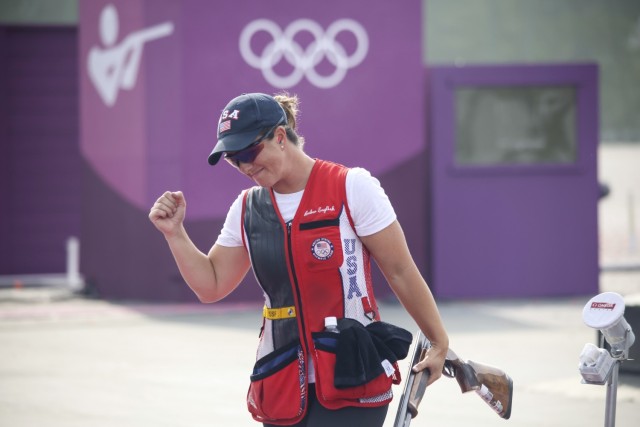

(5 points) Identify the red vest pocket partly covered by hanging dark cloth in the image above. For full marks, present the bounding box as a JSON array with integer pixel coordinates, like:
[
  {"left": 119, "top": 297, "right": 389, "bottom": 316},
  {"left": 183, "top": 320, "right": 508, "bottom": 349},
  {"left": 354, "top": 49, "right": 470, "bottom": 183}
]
[{"left": 312, "top": 332, "right": 393, "bottom": 400}]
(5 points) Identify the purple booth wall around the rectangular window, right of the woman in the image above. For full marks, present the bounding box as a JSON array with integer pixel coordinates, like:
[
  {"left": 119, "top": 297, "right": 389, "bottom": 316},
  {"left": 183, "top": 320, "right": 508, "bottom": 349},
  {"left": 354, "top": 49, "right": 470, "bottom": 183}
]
[{"left": 429, "top": 64, "right": 599, "bottom": 298}]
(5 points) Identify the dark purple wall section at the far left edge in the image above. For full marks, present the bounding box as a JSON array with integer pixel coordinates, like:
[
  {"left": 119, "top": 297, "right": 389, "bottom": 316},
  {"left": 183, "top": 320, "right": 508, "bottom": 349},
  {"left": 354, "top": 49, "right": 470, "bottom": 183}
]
[{"left": 0, "top": 27, "right": 81, "bottom": 274}]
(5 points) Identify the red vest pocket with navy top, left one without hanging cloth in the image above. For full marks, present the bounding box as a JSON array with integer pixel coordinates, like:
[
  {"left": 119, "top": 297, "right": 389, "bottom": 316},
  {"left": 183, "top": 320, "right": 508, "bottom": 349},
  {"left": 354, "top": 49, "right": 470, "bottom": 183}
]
[{"left": 247, "top": 341, "right": 307, "bottom": 422}]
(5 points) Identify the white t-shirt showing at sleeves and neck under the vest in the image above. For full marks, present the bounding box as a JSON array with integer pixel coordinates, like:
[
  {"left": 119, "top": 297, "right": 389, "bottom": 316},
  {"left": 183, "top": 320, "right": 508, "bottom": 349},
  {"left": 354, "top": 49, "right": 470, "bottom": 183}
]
[{"left": 216, "top": 168, "right": 396, "bottom": 247}]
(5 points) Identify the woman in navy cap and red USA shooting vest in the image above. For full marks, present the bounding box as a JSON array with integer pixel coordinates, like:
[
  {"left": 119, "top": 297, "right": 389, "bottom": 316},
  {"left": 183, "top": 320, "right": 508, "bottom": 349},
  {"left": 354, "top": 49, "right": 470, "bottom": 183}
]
[{"left": 149, "top": 93, "right": 449, "bottom": 427}]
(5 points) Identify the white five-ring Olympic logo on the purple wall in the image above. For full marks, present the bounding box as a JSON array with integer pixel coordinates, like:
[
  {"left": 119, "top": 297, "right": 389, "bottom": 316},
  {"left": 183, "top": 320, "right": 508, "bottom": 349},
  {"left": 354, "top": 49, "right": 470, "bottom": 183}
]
[{"left": 240, "top": 18, "right": 369, "bottom": 89}]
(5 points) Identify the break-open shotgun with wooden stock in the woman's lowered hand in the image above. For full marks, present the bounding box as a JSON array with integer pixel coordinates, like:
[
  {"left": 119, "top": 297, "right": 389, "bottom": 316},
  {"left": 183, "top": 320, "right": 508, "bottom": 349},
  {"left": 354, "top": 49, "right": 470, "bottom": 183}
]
[{"left": 393, "top": 331, "right": 513, "bottom": 427}]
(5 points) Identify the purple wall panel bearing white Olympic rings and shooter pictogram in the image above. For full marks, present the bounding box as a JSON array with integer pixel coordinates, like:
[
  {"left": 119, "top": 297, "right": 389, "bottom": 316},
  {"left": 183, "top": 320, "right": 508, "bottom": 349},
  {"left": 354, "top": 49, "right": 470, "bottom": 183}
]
[{"left": 79, "top": 0, "right": 426, "bottom": 299}]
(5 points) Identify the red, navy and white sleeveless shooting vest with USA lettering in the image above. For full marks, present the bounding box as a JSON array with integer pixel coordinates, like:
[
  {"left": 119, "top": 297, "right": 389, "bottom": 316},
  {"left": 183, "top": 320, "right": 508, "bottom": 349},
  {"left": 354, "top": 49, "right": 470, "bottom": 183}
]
[{"left": 242, "top": 160, "right": 400, "bottom": 425}]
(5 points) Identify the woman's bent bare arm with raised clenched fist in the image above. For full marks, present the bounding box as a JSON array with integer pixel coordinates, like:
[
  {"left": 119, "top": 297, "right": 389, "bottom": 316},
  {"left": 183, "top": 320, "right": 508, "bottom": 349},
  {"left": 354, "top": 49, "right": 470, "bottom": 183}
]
[{"left": 149, "top": 191, "right": 250, "bottom": 302}]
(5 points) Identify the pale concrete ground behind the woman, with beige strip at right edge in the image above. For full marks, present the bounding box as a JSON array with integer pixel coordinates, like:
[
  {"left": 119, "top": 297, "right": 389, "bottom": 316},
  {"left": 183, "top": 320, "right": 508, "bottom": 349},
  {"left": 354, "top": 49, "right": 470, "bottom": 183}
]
[{"left": 0, "top": 145, "right": 640, "bottom": 427}]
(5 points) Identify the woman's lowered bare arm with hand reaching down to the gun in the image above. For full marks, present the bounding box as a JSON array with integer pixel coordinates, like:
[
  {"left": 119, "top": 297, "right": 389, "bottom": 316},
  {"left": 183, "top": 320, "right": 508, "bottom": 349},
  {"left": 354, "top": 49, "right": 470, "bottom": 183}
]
[{"left": 361, "top": 221, "right": 449, "bottom": 384}]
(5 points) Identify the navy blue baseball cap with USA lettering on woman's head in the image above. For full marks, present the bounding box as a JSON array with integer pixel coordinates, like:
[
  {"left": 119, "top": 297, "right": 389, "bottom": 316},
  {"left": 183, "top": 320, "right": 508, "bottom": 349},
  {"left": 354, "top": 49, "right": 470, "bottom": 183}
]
[{"left": 209, "top": 93, "right": 287, "bottom": 165}]
